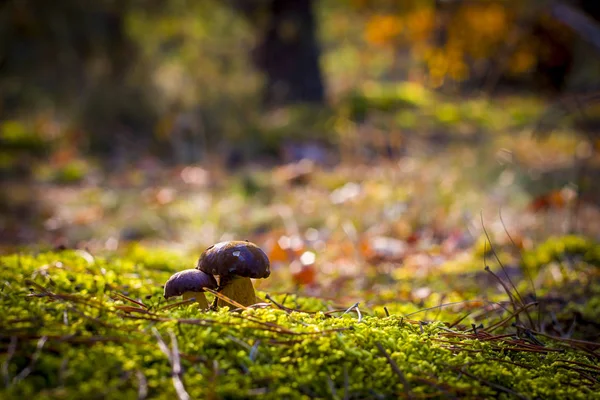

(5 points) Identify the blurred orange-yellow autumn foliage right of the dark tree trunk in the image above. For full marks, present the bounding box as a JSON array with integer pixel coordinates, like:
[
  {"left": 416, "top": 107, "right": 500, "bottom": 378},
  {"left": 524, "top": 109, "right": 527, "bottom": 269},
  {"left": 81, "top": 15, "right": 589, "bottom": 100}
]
[{"left": 364, "top": 2, "right": 537, "bottom": 86}]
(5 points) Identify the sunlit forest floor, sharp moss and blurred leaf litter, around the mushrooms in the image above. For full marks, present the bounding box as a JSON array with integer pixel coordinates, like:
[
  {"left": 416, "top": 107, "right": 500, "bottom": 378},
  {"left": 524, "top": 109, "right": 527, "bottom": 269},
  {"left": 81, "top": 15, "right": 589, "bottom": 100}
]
[{"left": 0, "top": 90, "right": 600, "bottom": 398}]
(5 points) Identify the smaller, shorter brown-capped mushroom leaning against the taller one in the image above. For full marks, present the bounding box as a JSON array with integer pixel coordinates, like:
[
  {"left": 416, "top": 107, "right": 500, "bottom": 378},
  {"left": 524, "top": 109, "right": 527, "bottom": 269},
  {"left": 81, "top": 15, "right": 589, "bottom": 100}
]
[{"left": 164, "top": 269, "right": 217, "bottom": 309}]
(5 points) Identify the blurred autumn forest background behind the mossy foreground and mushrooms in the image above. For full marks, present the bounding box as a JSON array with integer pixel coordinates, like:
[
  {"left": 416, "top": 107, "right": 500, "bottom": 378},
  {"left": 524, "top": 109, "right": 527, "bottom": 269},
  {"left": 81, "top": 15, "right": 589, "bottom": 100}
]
[{"left": 0, "top": 0, "right": 600, "bottom": 296}]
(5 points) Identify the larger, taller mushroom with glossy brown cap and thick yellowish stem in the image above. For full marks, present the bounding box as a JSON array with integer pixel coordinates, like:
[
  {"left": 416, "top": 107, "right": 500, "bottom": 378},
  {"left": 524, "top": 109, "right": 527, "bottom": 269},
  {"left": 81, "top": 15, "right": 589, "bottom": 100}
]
[{"left": 196, "top": 240, "right": 271, "bottom": 306}]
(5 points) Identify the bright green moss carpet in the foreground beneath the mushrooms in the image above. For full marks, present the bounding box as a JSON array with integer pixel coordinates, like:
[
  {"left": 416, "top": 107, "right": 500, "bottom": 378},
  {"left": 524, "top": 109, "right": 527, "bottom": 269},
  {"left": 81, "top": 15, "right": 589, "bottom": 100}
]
[{"left": 0, "top": 239, "right": 600, "bottom": 399}]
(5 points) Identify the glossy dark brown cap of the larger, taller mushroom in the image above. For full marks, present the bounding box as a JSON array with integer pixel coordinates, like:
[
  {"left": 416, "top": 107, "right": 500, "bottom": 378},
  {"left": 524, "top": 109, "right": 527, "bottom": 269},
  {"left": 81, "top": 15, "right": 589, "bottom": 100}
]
[{"left": 196, "top": 240, "right": 271, "bottom": 279}]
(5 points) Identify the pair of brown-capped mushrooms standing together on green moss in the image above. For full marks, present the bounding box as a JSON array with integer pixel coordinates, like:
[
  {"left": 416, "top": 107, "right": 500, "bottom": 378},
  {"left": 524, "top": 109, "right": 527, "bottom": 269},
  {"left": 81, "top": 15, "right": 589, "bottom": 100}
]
[{"left": 164, "top": 241, "right": 271, "bottom": 309}]
